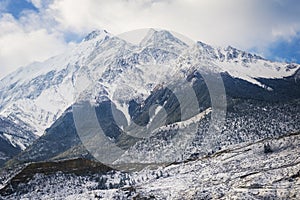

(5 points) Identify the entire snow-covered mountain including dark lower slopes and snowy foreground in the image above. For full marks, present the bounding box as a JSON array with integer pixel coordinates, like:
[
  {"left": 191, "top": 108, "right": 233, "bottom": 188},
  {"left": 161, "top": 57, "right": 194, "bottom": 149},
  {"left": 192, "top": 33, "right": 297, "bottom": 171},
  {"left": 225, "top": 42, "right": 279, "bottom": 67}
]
[{"left": 0, "top": 29, "right": 300, "bottom": 199}]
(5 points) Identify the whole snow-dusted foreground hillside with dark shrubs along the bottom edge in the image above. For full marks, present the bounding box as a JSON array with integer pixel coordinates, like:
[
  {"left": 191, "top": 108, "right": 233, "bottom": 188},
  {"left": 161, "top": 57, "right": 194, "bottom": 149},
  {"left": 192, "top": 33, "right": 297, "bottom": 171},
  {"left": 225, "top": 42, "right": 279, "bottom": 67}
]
[{"left": 1, "top": 133, "right": 300, "bottom": 200}]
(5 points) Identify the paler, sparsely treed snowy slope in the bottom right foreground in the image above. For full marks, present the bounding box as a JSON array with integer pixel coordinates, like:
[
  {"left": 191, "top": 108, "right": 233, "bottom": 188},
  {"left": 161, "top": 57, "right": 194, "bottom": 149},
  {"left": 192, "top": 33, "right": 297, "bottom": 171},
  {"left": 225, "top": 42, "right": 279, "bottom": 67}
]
[{"left": 132, "top": 134, "right": 300, "bottom": 199}]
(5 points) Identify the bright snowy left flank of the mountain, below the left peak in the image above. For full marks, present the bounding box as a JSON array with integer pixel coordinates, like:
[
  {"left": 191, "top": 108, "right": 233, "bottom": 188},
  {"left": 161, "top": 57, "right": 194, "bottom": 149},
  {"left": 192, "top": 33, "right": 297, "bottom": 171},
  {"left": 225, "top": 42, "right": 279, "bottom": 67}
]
[{"left": 0, "top": 31, "right": 109, "bottom": 135}]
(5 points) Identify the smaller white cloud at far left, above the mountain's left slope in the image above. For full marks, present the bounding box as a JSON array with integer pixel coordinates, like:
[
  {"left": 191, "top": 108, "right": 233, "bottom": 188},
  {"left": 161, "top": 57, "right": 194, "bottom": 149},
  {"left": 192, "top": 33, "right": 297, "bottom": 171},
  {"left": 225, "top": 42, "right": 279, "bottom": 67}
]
[{"left": 0, "top": 14, "right": 67, "bottom": 78}]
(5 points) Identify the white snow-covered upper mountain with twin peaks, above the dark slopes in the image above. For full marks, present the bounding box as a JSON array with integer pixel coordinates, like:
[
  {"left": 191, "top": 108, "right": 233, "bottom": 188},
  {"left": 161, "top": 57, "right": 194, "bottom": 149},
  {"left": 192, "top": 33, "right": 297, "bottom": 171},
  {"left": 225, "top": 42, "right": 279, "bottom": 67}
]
[{"left": 0, "top": 29, "right": 299, "bottom": 144}]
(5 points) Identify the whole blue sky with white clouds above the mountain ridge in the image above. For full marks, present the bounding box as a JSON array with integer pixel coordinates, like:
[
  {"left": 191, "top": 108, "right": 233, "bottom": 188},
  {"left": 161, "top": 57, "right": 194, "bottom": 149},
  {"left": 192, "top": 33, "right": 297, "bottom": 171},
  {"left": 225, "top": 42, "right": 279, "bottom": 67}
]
[{"left": 0, "top": 0, "right": 300, "bottom": 79}]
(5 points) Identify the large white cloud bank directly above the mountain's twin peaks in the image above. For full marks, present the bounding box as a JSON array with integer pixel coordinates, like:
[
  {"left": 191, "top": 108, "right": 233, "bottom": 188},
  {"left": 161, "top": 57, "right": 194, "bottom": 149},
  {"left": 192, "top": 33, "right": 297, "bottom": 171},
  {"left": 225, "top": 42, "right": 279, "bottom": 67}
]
[{"left": 50, "top": 0, "right": 300, "bottom": 48}]
